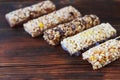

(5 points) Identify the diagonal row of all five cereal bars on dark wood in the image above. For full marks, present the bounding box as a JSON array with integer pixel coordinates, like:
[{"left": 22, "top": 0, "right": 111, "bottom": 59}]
[{"left": 5, "top": 0, "right": 120, "bottom": 69}]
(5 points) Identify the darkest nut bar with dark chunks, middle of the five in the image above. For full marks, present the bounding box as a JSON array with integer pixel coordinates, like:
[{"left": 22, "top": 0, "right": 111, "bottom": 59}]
[{"left": 43, "top": 15, "right": 100, "bottom": 46}]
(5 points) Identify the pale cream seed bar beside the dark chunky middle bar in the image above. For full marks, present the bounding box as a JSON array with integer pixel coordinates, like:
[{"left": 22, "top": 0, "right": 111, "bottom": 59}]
[{"left": 61, "top": 23, "right": 116, "bottom": 55}]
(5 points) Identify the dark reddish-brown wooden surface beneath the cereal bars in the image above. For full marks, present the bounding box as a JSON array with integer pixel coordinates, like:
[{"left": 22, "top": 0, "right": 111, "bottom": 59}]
[{"left": 0, "top": 0, "right": 120, "bottom": 80}]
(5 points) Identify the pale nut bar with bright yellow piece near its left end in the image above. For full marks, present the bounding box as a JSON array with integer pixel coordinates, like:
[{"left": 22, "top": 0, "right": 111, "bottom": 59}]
[{"left": 24, "top": 6, "right": 81, "bottom": 37}]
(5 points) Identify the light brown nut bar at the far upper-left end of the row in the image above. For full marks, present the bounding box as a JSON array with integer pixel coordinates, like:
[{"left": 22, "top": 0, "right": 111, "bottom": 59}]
[{"left": 5, "top": 0, "right": 56, "bottom": 27}]
